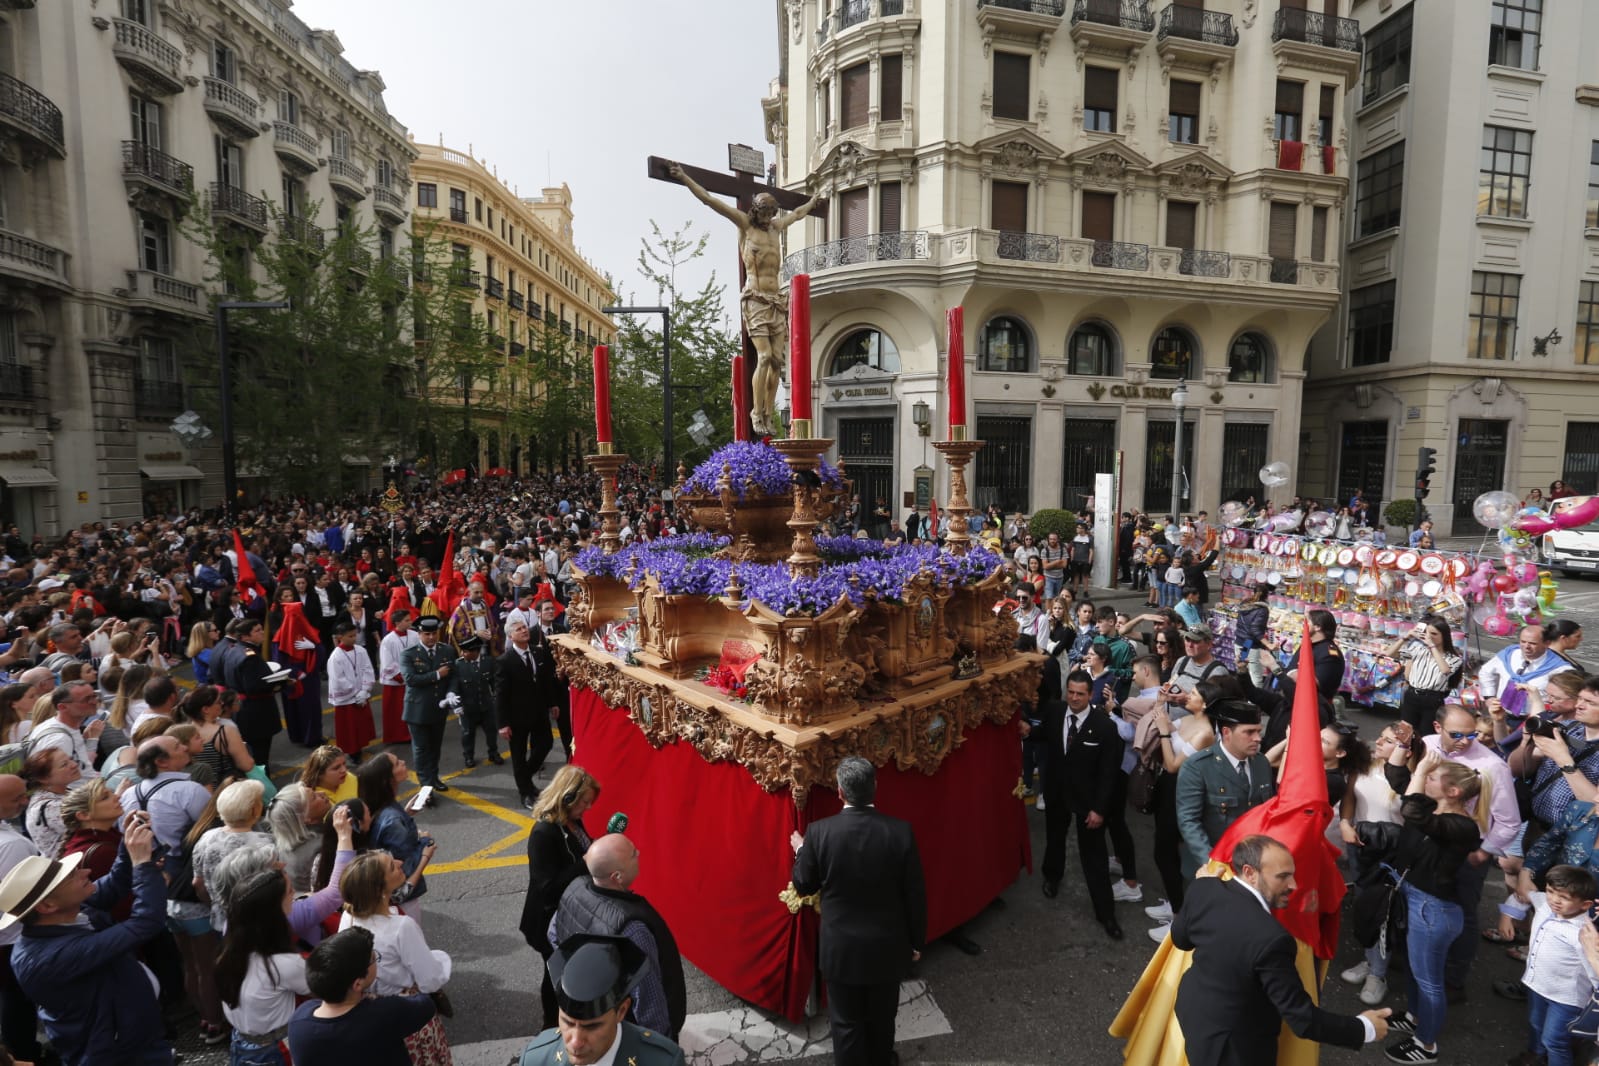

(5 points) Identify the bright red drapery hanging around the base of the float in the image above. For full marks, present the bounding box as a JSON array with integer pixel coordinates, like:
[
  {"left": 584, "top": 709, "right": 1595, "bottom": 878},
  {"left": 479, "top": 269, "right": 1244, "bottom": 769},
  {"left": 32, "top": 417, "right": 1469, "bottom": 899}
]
[{"left": 572, "top": 689, "right": 1031, "bottom": 1021}]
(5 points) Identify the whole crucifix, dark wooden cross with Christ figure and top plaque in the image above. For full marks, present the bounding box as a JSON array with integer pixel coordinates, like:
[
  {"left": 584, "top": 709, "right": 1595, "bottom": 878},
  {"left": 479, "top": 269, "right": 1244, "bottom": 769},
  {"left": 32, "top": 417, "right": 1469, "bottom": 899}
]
[{"left": 649, "top": 145, "right": 827, "bottom": 435}]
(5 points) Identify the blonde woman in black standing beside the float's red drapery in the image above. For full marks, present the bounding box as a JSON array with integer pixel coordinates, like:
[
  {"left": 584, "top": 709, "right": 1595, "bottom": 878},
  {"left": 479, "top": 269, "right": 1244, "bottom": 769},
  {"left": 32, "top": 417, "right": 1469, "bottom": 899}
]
[{"left": 521, "top": 762, "right": 600, "bottom": 1029}]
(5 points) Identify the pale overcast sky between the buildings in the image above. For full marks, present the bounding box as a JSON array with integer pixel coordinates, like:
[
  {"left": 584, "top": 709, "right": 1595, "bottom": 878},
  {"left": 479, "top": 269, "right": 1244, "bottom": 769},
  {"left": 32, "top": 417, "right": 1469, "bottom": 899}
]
[{"left": 294, "top": 0, "right": 777, "bottom": 315}]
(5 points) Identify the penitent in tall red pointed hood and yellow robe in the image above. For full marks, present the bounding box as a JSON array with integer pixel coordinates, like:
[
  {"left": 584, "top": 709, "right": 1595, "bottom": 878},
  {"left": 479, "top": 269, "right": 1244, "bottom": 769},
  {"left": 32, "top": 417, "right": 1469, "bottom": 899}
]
[{"left": 1110, "top": 622, "right": 1345, "bottom": 1066}]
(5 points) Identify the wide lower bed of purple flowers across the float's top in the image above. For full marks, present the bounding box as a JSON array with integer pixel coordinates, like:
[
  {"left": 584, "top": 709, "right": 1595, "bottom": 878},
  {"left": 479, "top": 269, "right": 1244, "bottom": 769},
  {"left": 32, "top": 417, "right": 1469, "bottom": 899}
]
[{"left": 576, "top": 534, "right": 1003, "bottom": 615}]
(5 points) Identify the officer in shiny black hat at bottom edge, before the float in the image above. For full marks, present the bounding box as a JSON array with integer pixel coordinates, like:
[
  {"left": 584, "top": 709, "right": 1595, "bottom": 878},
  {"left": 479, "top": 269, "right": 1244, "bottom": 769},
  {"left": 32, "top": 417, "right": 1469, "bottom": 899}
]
[{"left": 521, "top": 933, "right": 684, "bottom": 1066}]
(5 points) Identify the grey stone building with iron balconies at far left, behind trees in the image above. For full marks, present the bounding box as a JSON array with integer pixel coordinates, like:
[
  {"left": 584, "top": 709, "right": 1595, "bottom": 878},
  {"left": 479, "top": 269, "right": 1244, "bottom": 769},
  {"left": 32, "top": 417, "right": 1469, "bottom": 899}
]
[{"left": 0, "top": 0, "right": 416, "bottom": 534}]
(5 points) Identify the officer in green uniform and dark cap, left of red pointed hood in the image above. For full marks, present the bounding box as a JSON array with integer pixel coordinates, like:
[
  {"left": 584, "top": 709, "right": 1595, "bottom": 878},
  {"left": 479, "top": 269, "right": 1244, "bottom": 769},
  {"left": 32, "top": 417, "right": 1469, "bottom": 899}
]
[{"left": 1177, "top": 697, "right": 1278, "bottom": 877}]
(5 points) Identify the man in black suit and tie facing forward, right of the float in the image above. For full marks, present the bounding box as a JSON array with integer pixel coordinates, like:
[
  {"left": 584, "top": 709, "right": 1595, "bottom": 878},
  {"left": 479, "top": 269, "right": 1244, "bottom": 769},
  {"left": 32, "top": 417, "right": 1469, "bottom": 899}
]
[{"left": 1041, "top": 670, "right": 1122, "bottom": 940}]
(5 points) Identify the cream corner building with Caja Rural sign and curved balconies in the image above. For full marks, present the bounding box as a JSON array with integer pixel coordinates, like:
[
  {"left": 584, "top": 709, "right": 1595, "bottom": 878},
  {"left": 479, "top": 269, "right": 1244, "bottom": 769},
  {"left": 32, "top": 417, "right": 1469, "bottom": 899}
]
[{"left": 764, "top": 0, "right": 1361, "bottom": 513}]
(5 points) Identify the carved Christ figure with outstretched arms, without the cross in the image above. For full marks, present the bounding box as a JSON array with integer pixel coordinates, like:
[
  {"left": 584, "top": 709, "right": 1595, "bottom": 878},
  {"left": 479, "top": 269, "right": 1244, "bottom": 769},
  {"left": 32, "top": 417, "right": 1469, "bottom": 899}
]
[{"left": 668, "top": 163, "right": 819, "bottom": 436}]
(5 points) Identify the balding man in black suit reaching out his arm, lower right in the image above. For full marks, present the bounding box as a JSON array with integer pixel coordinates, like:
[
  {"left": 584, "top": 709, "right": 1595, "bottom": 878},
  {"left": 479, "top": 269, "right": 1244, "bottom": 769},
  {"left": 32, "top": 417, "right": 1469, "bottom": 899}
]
[{"left": 1172, "top": 836, "right": 1391, "bottom": 1066}]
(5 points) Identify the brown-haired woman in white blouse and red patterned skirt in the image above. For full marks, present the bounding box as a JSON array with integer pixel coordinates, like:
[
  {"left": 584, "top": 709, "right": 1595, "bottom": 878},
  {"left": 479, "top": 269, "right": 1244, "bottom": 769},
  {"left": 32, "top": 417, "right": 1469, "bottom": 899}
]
[{"left": 339, "top": 852, "right": 453, "bottom": 1066}]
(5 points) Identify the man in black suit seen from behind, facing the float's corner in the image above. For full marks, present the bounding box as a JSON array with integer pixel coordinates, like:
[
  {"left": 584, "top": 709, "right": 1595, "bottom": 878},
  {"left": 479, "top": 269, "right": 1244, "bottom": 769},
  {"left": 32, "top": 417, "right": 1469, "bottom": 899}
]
[{"left": 790, "top": 754, "right": 927, "bottom": 1066}]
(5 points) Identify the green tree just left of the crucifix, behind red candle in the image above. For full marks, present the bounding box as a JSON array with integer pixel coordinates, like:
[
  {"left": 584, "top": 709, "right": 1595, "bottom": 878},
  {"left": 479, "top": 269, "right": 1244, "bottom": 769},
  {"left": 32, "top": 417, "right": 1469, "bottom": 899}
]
[{"left": 611, "top": 222, "right": 740, "bottom": 476}]
